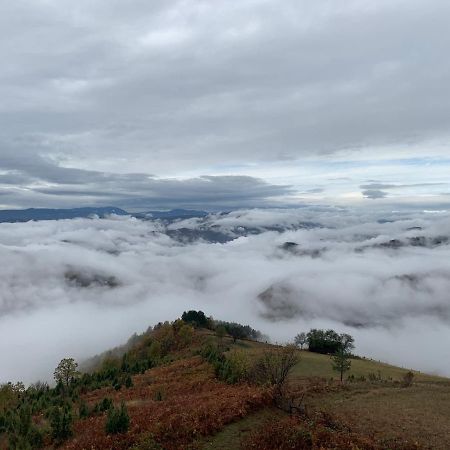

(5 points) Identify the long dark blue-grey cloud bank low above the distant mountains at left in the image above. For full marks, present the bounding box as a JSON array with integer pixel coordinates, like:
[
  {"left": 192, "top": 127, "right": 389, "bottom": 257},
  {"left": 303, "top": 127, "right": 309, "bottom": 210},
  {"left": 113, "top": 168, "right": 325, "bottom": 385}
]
[{"left": 0, "top": 145, "right": 294, "bottom": 211}]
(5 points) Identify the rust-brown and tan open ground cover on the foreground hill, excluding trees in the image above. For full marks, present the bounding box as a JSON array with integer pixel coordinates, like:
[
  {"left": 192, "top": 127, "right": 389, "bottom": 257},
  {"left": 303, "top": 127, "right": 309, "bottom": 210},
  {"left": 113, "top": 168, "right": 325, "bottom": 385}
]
[{"left": 0, "top": 330, "right": 442, "bottom": 450}]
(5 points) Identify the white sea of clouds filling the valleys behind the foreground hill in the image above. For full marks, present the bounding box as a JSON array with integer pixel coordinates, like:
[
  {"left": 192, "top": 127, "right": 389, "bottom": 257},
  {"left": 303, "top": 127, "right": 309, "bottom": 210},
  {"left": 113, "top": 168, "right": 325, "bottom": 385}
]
[{"left": 0, "top": 208, "right": 450, "bottom": 382}]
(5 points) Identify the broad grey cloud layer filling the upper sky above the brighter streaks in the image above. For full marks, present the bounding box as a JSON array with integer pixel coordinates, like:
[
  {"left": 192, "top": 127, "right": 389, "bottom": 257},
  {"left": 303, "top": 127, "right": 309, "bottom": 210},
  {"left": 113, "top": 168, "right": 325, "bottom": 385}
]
[{"left": 0, "top": 0, "right": 450, "bottom": 206}]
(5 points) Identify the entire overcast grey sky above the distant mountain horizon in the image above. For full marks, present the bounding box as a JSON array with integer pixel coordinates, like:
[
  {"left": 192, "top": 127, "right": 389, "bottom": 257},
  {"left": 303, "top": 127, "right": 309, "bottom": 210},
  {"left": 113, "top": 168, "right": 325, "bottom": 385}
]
[{"left": 0, "top": 0, "right": 450, "bottom": 210}]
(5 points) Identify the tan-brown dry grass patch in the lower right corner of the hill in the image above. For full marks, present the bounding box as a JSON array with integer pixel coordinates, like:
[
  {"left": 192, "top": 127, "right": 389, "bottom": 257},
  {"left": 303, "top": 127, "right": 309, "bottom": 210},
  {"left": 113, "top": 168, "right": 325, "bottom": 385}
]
[{"left": 306, "top": 382, "right": 450, "bottom": 449}]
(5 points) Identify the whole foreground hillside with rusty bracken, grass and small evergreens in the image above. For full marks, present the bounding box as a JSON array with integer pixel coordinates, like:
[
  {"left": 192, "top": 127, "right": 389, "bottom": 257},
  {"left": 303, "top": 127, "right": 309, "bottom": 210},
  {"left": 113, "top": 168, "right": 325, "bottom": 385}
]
[{"left": 0, "top": 317, "right": 450, "bottom": 450}]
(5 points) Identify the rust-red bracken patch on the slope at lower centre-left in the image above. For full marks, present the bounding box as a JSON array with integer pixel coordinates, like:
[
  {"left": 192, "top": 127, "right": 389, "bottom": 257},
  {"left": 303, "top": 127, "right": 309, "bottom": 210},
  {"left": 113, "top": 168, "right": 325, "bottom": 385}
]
[{"left": 63, "top": 357, "right": 271, "bottom": 450}]
